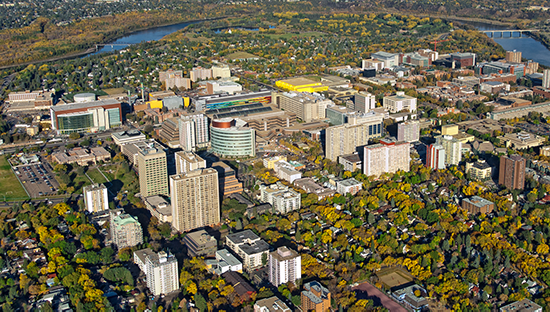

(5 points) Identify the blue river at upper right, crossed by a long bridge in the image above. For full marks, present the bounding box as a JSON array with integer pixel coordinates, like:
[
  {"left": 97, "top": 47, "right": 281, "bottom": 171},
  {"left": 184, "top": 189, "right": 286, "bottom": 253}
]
[{"left": 461, "top": 21, "right": 550, "bottom": 66}]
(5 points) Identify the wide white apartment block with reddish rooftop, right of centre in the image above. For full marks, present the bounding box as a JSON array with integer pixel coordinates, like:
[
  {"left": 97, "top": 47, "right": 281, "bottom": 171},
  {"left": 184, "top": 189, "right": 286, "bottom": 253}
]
[{"left": 363, "top": 140, "right": 411, "bottom": 176}]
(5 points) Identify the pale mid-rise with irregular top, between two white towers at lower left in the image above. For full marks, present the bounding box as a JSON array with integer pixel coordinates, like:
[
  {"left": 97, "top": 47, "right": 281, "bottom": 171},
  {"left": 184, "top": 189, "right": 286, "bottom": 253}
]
[{"left": 109, "top": 209, "right": 143, "bottom": 249}]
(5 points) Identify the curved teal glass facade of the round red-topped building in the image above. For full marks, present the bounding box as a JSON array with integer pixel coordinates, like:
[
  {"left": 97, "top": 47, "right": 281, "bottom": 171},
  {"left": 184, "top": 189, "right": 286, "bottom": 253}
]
[{"left": 210, "top": 127, "right": 256, "bottom": 158}]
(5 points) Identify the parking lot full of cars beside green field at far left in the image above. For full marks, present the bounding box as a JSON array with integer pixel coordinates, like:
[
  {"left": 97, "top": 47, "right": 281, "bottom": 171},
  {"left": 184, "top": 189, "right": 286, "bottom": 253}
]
[{"left": 13, "top": 163, "right": 59, "bottom": 198}]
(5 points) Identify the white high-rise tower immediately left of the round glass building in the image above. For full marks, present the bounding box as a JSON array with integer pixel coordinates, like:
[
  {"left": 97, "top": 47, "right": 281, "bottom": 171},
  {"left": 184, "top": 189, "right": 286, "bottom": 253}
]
[{"left": 178, "top": 114, "right": 210, "bottom": 151}]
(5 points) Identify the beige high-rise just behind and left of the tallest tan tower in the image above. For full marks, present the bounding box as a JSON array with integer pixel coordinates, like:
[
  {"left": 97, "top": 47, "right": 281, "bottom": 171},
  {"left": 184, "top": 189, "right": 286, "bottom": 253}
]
[{"left": 137, "top": 145, "right": 169, "bottom": 197}]
